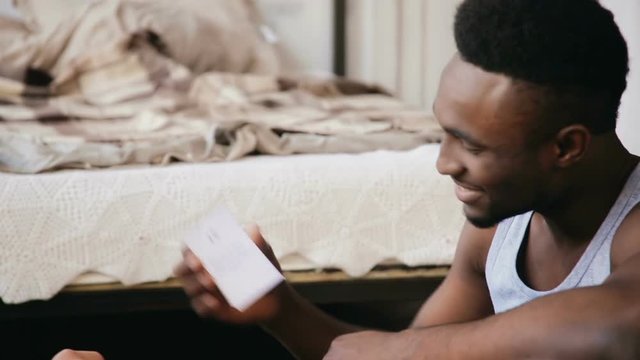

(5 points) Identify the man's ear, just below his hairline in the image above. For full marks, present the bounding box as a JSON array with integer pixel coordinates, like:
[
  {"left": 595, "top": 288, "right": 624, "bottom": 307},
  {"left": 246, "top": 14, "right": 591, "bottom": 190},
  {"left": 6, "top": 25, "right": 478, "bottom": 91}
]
[{"left": 554, "top": 124, "right": 591, "bottom": 168}]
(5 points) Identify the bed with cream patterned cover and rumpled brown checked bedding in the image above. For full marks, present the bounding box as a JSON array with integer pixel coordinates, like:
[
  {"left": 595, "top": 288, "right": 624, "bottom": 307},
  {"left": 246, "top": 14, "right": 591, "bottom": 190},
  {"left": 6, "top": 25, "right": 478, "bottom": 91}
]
[{"left": 0, "top": 1, "right": 463, "bottom": 315}]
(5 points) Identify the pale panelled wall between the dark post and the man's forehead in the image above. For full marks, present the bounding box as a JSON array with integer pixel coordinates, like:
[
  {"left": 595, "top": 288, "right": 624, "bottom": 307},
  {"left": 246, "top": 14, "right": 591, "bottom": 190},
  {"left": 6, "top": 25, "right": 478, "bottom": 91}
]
[{"left": 347, "top": 0, "right": 460, "bottom": 109}]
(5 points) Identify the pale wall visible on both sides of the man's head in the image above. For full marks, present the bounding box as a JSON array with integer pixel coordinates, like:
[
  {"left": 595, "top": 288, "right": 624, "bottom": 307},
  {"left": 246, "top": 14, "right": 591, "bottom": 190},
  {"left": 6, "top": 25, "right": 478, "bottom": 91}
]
[{"left": 347, "top": 0, "right": 640, "bottom": 155}]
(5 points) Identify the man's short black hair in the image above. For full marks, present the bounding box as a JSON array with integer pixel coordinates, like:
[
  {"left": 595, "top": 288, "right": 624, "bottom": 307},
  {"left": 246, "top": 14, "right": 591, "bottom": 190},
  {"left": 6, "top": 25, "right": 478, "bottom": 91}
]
[{"left": 454, "top": 0, "right": 629, "bottom": 133}]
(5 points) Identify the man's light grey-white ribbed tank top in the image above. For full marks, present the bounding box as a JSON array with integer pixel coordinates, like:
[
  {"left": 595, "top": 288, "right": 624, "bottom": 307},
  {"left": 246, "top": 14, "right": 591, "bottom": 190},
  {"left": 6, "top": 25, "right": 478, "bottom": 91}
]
[{"left": 485, "top": 164, "right": 640, "bottom": 314}]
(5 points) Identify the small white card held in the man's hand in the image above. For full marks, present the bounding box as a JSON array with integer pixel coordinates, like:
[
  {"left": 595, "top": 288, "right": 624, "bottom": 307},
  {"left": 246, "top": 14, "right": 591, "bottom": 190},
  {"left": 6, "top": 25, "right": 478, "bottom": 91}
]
[{"left": 186, "top": 208, "right": 284, "bottom": 311}]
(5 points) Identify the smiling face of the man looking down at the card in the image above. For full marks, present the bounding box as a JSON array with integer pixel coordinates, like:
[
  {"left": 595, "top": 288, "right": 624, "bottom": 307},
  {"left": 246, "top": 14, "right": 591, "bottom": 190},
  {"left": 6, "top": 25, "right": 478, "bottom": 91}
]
[{"left": 434, "top": 56, "right": 552, "bottom": 227}]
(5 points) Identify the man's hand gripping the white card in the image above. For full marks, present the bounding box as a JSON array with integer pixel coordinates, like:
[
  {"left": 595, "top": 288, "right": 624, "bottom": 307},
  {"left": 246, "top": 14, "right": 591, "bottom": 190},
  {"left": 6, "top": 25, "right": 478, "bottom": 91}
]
[{"left": 174, "top": 225, "right": 290, "bottom": 324}]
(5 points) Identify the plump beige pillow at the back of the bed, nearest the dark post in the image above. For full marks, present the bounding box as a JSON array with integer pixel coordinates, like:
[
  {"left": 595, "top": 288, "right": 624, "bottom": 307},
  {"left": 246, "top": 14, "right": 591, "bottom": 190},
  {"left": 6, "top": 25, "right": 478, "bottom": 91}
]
[{"left": 120, "top": 0, "right": 279, "bottom": 74}]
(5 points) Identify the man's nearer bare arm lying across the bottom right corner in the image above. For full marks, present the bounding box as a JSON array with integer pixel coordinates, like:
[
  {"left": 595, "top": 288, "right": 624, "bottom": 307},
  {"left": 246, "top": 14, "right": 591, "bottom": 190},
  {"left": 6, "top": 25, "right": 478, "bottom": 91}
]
[{"left": 327, "top": 211, "right": 640, "bottom": 360}]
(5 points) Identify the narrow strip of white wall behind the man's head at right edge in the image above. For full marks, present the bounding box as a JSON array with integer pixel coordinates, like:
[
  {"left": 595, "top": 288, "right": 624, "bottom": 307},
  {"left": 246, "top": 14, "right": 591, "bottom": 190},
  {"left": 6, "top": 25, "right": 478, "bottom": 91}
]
[{"left": 601, "top": 0, "right": 640, "bottom": 155}]
